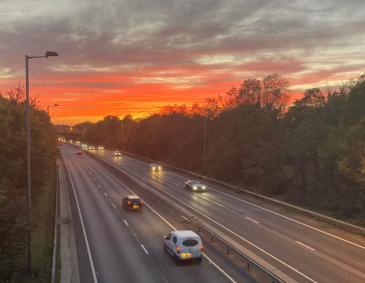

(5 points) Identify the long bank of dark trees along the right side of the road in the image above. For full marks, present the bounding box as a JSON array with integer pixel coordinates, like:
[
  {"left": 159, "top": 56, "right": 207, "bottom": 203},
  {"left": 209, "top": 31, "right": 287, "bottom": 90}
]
[{"left": 68, "top": 74, "right": 365, "bottom": 225}]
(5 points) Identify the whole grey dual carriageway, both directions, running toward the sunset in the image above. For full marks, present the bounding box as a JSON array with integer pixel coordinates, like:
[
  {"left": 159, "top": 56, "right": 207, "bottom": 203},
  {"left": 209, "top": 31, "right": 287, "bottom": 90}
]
[{"left": 61, "top": 143, "right": 365, "bottom": 282}]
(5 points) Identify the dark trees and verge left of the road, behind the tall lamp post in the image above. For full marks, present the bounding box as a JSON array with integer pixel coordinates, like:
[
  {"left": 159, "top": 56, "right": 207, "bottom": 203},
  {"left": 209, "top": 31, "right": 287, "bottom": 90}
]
[{"left": 0, "top": 87, "right": 57, "bottom": 282}]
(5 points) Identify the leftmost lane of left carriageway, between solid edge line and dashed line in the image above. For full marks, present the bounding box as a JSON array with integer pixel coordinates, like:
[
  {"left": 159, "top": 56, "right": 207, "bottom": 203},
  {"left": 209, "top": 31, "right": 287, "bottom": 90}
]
[{"left": 64, "top": 150, "right": 164, "bottom": 282}]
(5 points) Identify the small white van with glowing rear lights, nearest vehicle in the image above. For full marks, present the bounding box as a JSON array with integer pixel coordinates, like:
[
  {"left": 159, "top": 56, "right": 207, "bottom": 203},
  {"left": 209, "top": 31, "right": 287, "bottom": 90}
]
[{"left": 164, "top": 230, "right": 203, "bottom": 262}]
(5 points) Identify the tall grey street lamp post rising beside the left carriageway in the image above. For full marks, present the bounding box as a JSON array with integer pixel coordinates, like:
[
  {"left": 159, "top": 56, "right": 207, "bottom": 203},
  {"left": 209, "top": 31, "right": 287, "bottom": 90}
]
[{"left": 25, "top": 51, "right": 58, "bottom": 273}]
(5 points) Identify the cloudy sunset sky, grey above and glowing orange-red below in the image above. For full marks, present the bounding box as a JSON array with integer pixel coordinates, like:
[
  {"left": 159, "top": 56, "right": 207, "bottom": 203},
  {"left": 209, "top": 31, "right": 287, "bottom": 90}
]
[{"left": 0, "top": 0, "right": 365, "bottom": 124}]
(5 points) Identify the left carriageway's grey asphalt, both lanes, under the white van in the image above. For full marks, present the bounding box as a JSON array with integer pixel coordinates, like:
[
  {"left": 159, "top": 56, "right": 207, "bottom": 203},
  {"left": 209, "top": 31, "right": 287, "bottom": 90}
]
[{"left": 62, "top": 147, "right": 235, "bottom": 282}]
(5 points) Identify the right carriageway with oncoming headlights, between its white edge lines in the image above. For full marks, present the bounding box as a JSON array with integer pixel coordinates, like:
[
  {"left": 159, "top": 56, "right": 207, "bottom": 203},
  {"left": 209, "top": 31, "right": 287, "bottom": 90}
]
[{"left": 86, "top": 146, "right": 365, "bottom": 282}]
